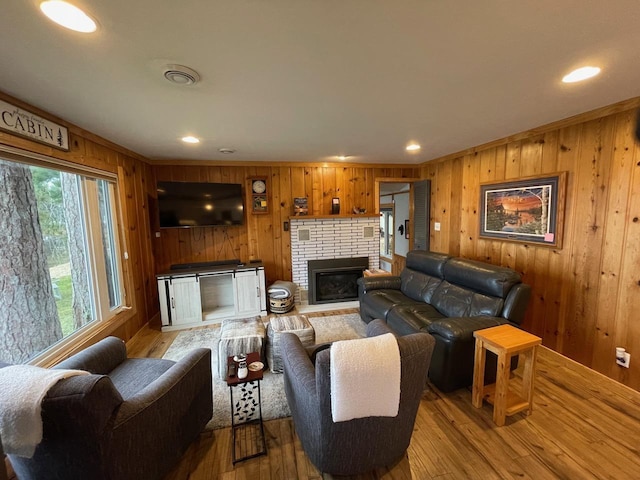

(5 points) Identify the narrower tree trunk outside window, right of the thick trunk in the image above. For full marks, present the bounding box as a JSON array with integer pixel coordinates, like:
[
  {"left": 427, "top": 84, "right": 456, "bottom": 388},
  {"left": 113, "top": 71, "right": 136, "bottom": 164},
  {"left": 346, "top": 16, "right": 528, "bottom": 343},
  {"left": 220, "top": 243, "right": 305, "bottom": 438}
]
[{"left": 60, "top": 173, "right": 92, "bottom": 330}]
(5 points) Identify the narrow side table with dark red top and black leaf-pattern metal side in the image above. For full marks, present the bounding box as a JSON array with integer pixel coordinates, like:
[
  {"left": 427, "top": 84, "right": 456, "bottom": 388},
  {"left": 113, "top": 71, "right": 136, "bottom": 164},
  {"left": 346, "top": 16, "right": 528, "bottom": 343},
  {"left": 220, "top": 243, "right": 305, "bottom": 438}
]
[{"left": 225, "top": 352, "right": 267, "bottom": 465}]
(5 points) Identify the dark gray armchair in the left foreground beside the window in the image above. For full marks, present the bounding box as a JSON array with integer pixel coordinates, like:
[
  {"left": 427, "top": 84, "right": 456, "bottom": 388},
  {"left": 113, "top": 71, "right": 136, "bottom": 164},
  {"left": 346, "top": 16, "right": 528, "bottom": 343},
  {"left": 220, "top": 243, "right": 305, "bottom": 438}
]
[{"left": 9, "top": 337, "right": 213, "bottom": 480}]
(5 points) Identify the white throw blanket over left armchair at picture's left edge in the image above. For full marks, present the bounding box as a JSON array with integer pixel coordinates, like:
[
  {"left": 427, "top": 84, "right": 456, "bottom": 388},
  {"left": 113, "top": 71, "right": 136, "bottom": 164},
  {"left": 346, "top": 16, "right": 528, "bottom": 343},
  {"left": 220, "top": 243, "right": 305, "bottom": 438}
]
[{"left": 0, "top": 365, "right": 89, "bottom": 458}]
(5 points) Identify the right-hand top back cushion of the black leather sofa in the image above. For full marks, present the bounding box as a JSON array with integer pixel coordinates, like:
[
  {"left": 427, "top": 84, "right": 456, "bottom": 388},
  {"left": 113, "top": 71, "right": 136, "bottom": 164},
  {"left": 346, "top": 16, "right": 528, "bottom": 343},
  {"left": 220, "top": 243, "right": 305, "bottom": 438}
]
[{"left": 444, "top": 258, "right": 521, "bottom": 298}]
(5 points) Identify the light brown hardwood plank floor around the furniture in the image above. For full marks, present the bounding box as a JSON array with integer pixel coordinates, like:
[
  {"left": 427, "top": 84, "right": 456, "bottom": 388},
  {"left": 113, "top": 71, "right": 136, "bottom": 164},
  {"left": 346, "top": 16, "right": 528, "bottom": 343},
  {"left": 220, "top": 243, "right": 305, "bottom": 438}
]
[{"left": 128, "top": 310, "right": 640, "bottom": 480}]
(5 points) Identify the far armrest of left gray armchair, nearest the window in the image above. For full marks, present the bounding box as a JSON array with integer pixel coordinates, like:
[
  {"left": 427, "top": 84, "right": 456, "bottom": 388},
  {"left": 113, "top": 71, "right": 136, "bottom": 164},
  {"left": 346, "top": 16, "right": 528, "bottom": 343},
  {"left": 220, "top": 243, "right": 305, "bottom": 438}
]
[{"left": 53, "top": 337, "right": 127, "bottom": 375}]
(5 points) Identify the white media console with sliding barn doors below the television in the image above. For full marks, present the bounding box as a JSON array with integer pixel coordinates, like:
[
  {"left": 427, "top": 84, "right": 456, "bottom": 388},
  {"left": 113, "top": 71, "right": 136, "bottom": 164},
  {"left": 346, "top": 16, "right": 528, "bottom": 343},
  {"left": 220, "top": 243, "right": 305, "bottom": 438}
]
[{"left": 156, "top": 263, "right": 267, "bottom": 331}]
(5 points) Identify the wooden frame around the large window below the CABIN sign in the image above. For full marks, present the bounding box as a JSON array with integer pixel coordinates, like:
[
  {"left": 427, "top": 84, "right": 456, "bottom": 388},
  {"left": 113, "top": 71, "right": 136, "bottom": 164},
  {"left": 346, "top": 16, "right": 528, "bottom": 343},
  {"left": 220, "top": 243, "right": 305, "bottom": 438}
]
[{"left": 0, "top": 144, "right": 137, "bottom": 368}]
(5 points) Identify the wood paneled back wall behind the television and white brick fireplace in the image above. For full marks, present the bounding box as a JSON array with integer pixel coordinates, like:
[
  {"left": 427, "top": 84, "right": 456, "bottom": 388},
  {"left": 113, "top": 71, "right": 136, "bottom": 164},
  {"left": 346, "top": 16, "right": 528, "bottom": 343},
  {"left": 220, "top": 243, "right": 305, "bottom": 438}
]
[{"left": 152, "top": 164, "right": 419, "bottom": 284}]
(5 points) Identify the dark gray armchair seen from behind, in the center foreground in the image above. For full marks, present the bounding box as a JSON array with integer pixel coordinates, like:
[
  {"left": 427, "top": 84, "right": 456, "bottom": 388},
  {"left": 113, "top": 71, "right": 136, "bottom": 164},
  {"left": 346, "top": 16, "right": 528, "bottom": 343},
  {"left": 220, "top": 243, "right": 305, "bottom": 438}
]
[{"left": 281, "top": 320, "right": 435, "bottom": 475}]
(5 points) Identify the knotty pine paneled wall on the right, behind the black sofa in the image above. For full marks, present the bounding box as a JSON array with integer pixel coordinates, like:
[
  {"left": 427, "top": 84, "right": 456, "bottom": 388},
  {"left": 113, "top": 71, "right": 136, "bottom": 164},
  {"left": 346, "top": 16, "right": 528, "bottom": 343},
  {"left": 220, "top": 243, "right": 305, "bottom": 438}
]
[{"left": 422, "top": 99, "right": 640, "bottom": 390}]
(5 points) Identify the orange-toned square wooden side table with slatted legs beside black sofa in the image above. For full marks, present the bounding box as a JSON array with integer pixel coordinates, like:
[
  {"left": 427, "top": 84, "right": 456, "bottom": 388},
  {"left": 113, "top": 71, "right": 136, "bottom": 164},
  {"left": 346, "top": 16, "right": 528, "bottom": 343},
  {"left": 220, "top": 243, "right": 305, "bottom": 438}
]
[{"left": 472, "top": 325, "right": 542, "bottom": 427}]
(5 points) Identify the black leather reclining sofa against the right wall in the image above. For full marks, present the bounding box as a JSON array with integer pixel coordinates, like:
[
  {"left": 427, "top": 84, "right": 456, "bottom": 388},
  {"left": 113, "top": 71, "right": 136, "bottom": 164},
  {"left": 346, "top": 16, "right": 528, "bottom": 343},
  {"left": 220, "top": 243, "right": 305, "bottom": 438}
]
[{"left": 358, "top": 250, "right": 531, "bottom": 392}]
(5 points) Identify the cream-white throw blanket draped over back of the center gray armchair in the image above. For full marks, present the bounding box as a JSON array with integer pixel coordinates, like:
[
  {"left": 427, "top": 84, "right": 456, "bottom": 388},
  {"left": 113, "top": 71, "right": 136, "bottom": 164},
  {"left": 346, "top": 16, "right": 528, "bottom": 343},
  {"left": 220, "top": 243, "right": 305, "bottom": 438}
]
[{"left": 331, "top": 333, "right": 400, "bottom": 422}]
